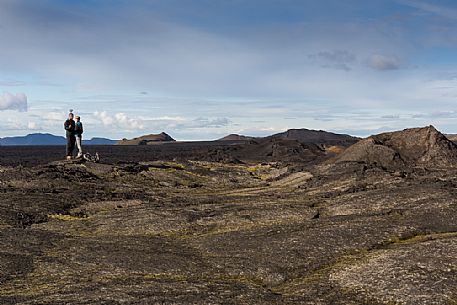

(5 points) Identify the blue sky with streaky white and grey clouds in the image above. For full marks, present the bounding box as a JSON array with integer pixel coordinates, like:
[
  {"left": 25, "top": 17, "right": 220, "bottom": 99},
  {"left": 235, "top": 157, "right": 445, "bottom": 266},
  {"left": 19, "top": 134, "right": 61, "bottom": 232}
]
[{"left": 0, "top": 0, "right": 457, "bottom": 140}]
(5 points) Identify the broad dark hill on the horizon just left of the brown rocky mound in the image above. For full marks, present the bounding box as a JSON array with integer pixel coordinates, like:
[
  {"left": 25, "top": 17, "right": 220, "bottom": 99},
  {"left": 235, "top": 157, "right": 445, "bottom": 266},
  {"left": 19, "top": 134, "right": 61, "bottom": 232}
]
[{"left": 266, "top": 129, "right": 360, "bottom": 147}]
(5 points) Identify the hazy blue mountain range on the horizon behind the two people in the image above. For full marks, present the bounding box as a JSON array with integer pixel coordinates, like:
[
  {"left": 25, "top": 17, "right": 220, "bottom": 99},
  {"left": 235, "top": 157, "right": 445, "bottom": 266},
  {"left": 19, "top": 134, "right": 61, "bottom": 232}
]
[{"left": 0, "top": 133, "right": 116, "bottom": 146}]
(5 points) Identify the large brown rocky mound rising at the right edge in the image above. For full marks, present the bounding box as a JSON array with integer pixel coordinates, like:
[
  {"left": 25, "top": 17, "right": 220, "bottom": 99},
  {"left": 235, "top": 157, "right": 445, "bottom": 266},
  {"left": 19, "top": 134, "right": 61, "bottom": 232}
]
[{"left": 336, "top": 126, "right": 457, "bottom": 168}]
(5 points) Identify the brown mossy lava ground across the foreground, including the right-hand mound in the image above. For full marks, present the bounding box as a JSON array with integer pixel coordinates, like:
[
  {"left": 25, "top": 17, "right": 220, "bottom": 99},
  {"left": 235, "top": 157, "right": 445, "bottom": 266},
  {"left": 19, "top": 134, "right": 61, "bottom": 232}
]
[{"left": 0, "top": 128, "right": 457, "bottom": 305}]
